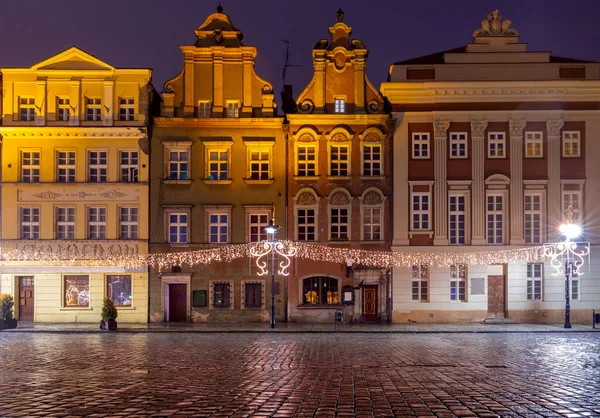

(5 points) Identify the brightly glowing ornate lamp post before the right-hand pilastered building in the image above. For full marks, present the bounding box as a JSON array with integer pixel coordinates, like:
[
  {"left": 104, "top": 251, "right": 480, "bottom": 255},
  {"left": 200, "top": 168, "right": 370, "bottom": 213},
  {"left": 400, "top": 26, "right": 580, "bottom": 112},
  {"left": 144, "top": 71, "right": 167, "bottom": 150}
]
[{"left": 544, "top": 206, "right": 590, "bottom": 328}]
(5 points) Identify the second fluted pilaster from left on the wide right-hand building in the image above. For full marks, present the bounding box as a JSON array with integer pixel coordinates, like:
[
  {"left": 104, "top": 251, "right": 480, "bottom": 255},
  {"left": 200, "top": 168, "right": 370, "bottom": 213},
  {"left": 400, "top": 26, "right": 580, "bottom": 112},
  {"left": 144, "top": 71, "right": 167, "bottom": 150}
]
[{"left": 471, "top": 120, "right": 487, "bottom": 245}]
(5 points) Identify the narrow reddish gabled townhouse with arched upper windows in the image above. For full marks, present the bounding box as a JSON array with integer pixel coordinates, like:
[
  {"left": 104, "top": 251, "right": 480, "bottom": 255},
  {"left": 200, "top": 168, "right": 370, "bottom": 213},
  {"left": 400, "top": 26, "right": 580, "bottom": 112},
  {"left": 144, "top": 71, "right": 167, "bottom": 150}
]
[{"left": 287, "top": 10, "right": 392, "bottom": 323}]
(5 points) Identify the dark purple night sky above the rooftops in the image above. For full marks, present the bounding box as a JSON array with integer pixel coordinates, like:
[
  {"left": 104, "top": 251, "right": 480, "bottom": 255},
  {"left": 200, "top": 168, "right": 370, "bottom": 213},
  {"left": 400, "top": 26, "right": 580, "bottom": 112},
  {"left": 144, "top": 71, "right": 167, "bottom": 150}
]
[{"left": 0, "top": 0, "right": 600, "bottom": 103}]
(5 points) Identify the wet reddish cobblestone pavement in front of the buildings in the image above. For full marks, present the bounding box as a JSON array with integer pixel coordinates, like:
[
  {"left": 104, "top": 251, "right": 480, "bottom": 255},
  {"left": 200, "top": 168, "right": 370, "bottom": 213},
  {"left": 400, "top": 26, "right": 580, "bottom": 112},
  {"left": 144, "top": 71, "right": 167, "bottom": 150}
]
[{"left": 0, "top": 333, "right": 600, "bottom": 417}]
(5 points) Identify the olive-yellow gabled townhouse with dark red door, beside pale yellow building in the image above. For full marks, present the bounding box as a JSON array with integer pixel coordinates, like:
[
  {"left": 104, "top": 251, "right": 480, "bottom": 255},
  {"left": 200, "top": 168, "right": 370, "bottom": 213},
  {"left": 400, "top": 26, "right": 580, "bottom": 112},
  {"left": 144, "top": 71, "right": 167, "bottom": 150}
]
[{"left": 150, "top": 6, "right": 285, "bottom": 322}]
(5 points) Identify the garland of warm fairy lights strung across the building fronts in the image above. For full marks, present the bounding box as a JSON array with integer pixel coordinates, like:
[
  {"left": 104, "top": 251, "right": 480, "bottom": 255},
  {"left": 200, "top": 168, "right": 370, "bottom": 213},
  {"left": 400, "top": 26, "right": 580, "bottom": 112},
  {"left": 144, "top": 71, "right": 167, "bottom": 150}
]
[{"left": 0, "top": 240, "right": 547, "bottom": 270}]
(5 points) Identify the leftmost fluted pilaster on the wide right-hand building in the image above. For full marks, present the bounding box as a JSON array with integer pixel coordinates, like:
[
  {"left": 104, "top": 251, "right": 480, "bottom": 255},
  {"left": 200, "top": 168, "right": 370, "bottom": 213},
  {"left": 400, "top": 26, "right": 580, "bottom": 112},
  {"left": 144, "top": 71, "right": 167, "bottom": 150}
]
[{"left": 433, "top": 119, "right": 450, "bottom": 245}]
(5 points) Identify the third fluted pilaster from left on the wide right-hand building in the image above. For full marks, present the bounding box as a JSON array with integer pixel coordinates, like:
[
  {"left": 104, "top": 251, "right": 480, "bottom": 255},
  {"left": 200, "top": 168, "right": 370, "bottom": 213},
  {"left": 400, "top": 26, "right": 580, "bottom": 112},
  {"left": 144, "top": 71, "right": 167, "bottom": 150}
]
[{"left": 509, "top": 119, "right": 527, "bottom": 245}]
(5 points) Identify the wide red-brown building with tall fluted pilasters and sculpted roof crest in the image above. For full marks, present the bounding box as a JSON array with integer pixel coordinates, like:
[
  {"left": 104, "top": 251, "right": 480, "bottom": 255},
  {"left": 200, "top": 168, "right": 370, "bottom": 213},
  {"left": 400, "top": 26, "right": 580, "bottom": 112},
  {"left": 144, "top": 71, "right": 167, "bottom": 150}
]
[{"left": 381, "top": 11, "right": 600, "bottom": 323}]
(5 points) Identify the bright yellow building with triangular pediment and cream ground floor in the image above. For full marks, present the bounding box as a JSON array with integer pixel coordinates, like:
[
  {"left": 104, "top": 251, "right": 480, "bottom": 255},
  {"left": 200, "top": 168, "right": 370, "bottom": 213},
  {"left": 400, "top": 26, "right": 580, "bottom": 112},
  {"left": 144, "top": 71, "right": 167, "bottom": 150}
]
[{"left": 0, "top": 47, "right": 156, "bottom": 322}]
